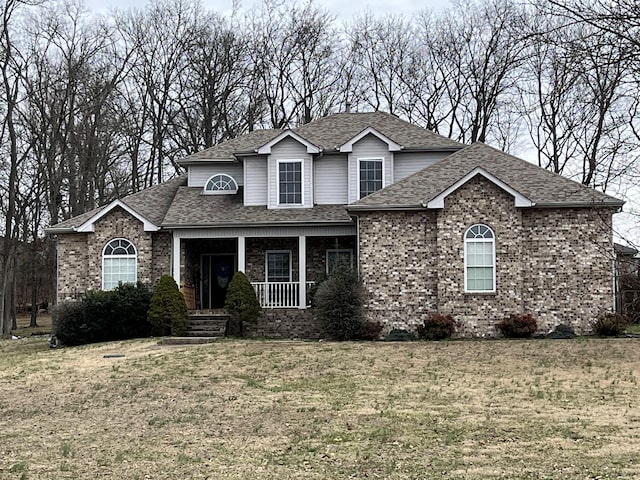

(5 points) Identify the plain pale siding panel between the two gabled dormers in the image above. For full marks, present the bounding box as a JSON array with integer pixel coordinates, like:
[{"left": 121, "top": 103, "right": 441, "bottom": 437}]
[{"left": 313, "top": 155, "right": 349, "bottom": 205}]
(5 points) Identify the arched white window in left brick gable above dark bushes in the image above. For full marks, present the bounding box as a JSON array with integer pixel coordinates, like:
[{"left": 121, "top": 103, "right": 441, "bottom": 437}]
[{"left": 102, "top": 238, "right": 138, "bottom": 290}]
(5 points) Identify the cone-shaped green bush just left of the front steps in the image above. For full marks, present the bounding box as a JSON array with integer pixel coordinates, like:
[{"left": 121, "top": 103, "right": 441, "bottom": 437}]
[{"left": 147, "top": 275, "right": 189, "bottom": 336}]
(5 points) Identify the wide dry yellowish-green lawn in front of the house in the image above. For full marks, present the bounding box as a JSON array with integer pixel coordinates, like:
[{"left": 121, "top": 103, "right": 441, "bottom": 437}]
[{"left": 0, "top": 338, "right": 640, "bottom": 480}]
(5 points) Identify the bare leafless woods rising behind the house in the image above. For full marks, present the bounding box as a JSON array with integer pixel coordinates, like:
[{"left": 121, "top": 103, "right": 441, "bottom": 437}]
[{"left": 0, "top": 0, "right": 640, "bottom": 333}]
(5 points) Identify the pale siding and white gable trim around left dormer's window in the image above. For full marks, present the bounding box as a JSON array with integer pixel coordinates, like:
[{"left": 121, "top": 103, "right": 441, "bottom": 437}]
[{"left": 267, "top": 137, "right": 313, "bottom": 208}]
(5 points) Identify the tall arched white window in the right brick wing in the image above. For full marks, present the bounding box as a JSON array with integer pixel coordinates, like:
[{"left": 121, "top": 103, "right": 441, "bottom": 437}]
[{"left": 464, "top": 224, "right": 496, "bottom": 292}]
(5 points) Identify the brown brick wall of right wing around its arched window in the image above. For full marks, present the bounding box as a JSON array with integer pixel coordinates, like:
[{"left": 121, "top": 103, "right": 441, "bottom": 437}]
[{"left": 359, "top": 176, "right": 613, "bottom": 337}]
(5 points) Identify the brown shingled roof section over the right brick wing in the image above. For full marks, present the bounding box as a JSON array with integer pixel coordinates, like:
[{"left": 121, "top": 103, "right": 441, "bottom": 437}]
[{"left": 348, "top": 142, "right": 624, "bottom": 211}]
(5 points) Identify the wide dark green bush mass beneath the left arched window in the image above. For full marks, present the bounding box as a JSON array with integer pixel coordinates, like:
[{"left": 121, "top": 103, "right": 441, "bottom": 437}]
[{"left": 53, "top": 282, "right": 151, "bottom": 346}]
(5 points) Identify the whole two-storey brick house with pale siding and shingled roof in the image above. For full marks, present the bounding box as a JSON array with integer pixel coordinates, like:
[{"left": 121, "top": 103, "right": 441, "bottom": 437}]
[{"left": 48, "top": 112, "right": 623, "bottom": 337}]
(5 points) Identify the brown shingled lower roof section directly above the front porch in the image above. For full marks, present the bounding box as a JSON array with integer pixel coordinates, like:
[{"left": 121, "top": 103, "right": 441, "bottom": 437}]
[{"left": 162, "top": 187, "right": 353, "bottom": 228}]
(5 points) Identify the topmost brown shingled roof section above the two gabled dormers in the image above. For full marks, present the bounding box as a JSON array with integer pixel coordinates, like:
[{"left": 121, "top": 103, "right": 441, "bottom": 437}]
[{"left": 180, "top": 112, "right": 463, "bottom": 164}]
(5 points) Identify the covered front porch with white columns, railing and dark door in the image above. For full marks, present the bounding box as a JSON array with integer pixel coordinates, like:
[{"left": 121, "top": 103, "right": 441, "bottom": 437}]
[{"left": 172, "top": 227, "right": 357, "bottom": 310}]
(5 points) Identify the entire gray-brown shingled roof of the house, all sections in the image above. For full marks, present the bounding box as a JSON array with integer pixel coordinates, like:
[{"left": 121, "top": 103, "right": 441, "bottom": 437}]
[{"left": 49, "top": 112, "right": 623, "bottom": 233}]
